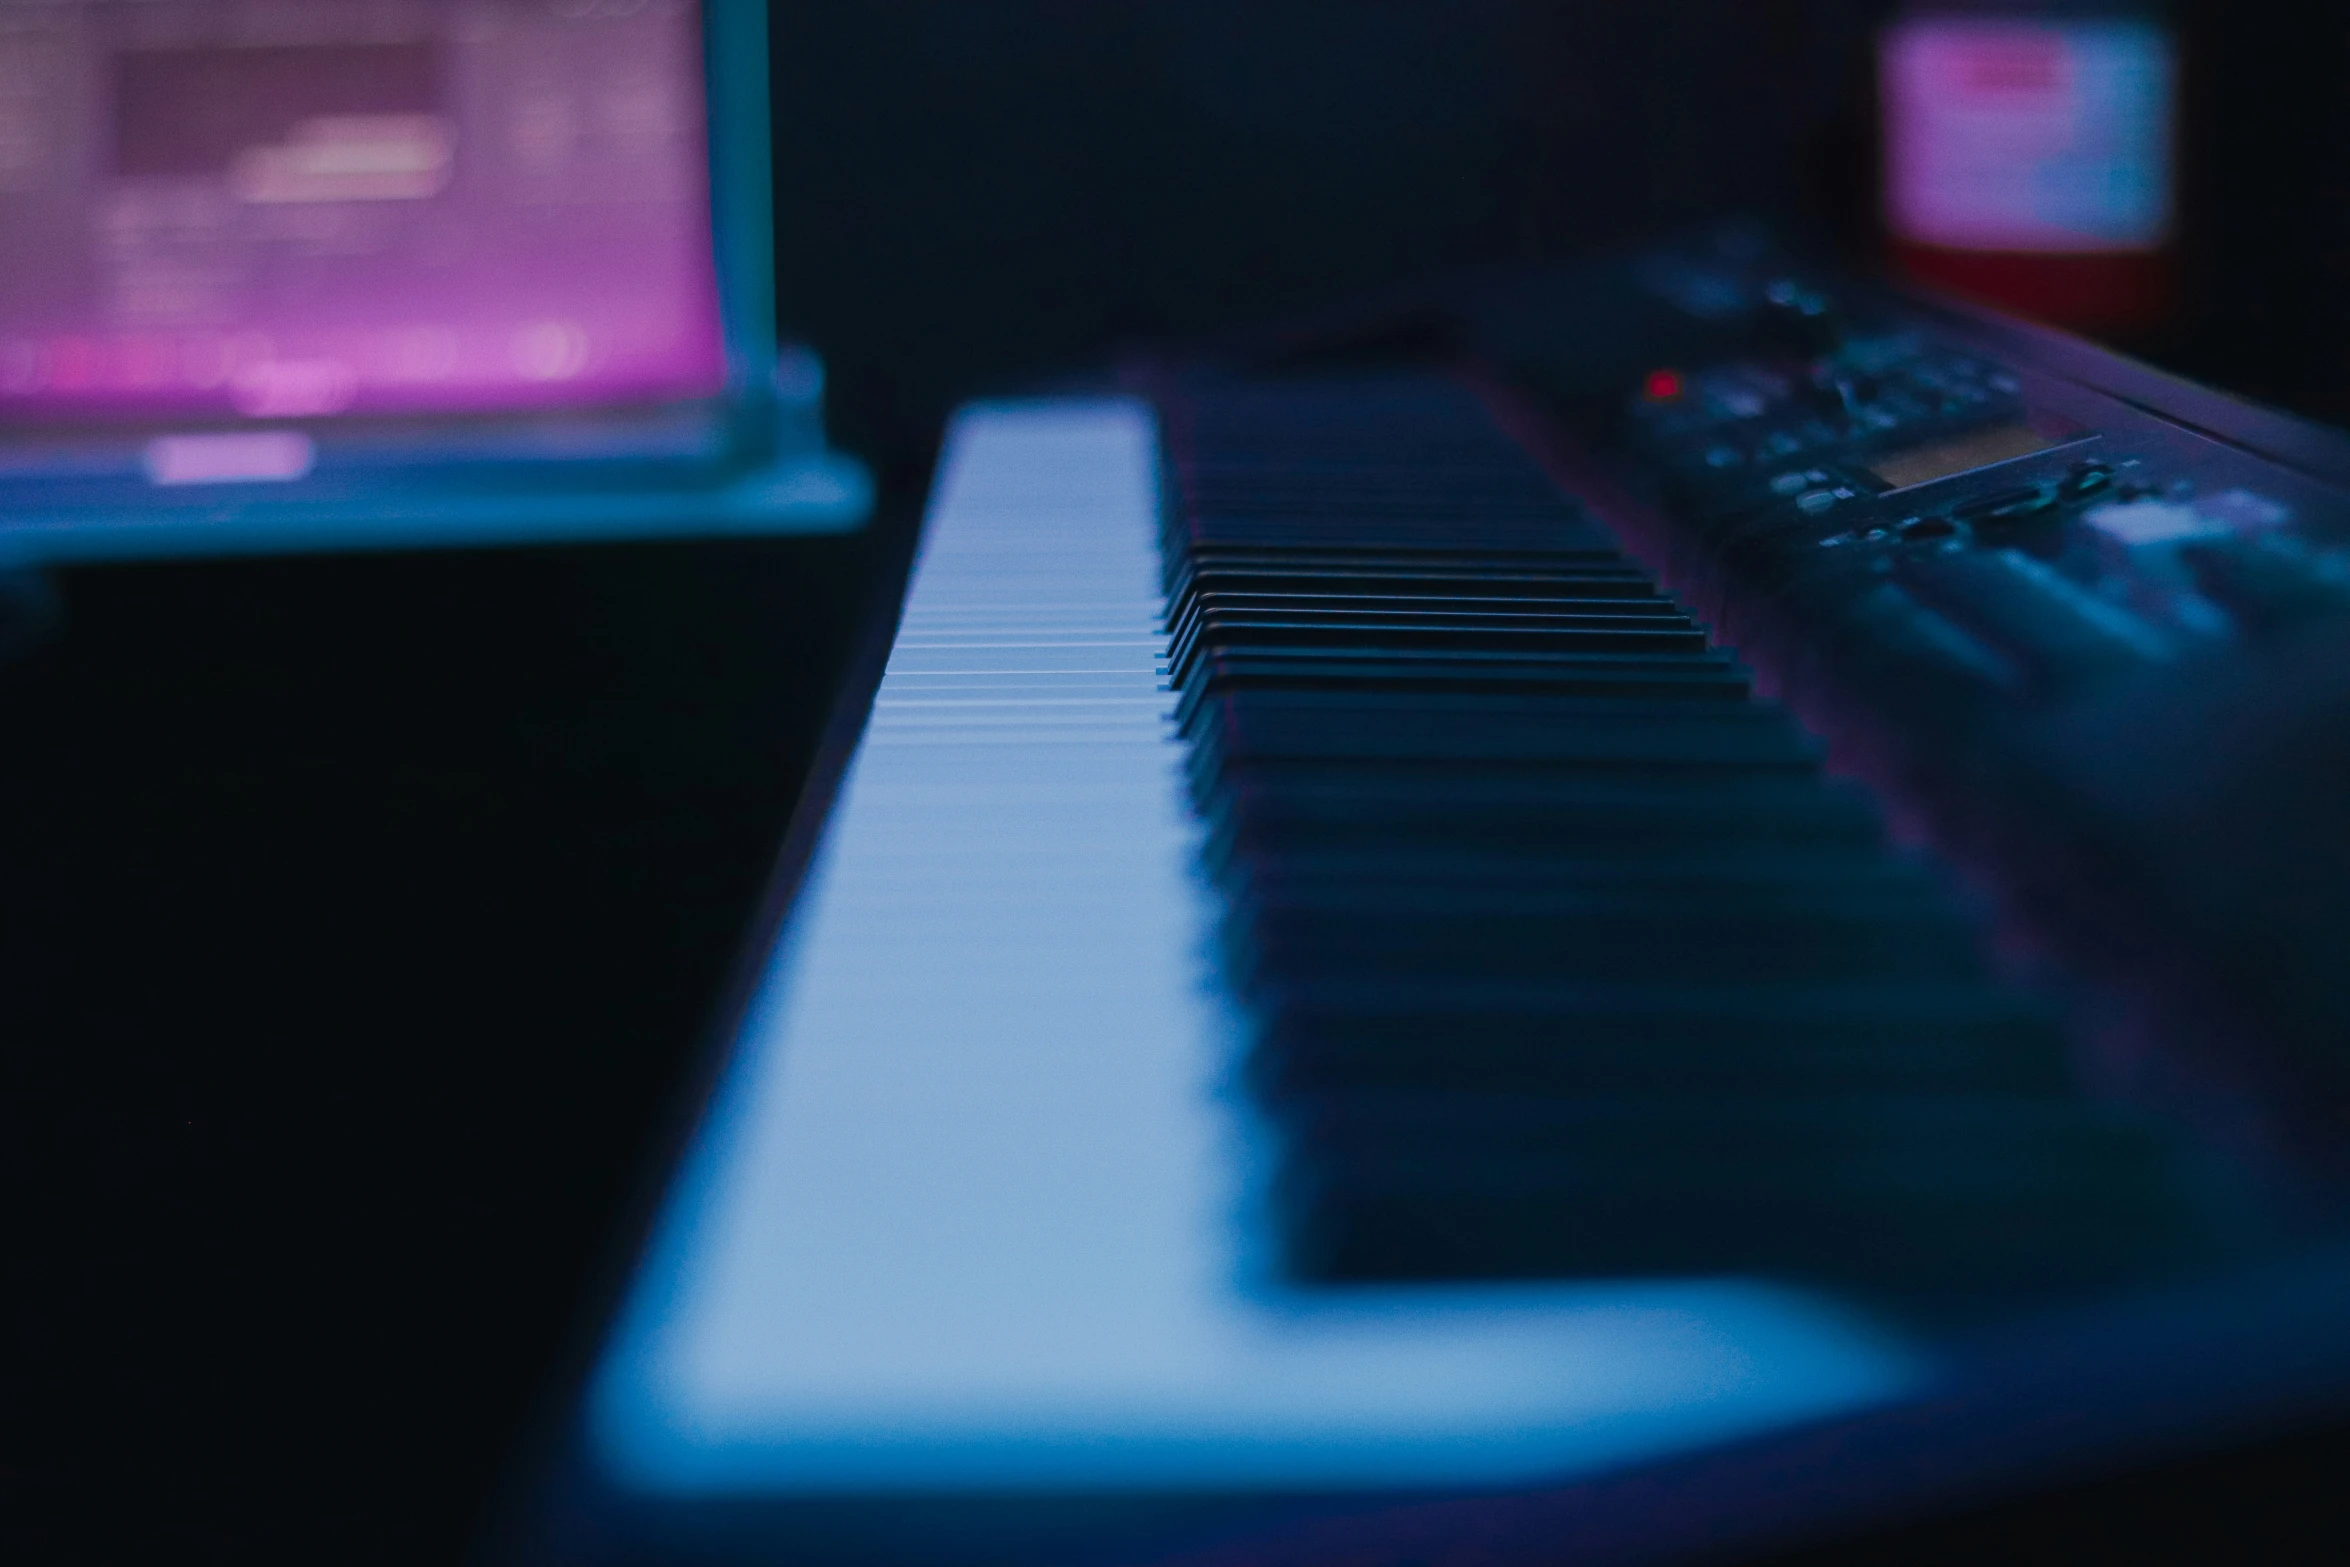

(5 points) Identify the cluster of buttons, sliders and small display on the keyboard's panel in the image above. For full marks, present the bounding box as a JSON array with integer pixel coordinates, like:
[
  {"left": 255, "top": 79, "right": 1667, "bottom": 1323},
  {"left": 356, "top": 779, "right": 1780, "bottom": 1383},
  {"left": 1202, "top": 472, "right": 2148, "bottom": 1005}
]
[{"left": 1626, "top": 284, "right": 2321, "bottom": 691}]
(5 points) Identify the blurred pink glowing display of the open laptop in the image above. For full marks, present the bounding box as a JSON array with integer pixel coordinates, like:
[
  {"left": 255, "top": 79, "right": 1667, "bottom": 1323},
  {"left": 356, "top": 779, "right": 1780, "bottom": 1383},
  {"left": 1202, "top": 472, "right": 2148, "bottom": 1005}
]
[{"left": 0, "top": 0, "right": 724, "bottom": 421}]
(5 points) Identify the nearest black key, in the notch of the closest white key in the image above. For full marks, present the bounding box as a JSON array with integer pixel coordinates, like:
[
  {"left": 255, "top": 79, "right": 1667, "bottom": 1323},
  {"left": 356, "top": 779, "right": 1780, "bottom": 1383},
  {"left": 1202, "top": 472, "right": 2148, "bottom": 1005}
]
[{"left": 1281, "top": 1092, "right": 2193, "bottom": 1292}]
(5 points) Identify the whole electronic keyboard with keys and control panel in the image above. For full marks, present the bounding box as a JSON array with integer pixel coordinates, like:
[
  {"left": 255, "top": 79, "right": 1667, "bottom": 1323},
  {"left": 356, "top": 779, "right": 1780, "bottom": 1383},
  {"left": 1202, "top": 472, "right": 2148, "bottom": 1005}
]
[{"left": 517, "top": 233, "right": 2350, "bottom": 1562}]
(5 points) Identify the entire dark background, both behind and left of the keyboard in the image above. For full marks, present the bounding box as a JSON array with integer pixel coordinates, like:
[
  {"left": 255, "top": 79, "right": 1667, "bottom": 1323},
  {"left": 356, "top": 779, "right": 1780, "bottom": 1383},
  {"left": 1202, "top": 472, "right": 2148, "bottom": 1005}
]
[{"left": 0, "top": 0, "right": 2350, "bottom": 1562}]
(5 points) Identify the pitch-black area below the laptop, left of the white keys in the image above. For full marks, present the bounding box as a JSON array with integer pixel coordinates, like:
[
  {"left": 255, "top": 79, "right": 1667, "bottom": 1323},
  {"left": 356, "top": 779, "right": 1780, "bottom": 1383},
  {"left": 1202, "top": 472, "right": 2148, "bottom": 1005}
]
[{"left": 0, "top": 521, "right": 902, "bottom": 1567}]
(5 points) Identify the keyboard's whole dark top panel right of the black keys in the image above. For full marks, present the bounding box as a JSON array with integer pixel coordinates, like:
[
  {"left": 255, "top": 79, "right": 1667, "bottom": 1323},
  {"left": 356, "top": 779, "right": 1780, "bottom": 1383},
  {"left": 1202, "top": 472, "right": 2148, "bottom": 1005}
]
[{"left": 1455, "top": 230, "right": 2350, "bottom": 1188}]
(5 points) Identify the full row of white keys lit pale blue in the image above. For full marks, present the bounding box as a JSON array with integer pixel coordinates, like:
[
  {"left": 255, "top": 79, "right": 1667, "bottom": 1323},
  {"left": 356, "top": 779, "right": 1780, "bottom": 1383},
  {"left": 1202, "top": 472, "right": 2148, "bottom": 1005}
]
[{"left": 590, "top": 399, "right": 1925, "bottom": 1494}]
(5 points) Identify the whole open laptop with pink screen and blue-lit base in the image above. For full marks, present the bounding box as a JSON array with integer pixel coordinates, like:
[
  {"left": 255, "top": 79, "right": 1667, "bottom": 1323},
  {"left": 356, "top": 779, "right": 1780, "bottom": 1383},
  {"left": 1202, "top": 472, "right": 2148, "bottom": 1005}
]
[{"left": 0, "top": 0, "right": 872, "bottom": 566}]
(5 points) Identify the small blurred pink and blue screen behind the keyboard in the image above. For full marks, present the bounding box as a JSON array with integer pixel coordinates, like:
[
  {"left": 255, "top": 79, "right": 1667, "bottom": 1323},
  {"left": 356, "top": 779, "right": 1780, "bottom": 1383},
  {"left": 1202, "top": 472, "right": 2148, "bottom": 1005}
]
[{"left": 1882, "top": 19, "right": 2176, "bottom": 254}]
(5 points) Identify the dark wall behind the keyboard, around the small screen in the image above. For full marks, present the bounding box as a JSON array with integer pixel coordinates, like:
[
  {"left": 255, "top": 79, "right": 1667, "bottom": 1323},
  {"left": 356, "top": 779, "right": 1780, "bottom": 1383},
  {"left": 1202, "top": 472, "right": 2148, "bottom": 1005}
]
[{"left": 773, "top": 0, "right": 2350, "bottom": 472}]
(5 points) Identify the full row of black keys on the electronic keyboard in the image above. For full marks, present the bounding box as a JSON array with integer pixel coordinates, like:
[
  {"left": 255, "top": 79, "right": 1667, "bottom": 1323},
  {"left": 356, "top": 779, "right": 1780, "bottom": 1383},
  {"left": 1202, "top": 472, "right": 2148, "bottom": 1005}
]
[{"left": 1163, "top": 374, "right": 2200, "bottom": 1311}]
